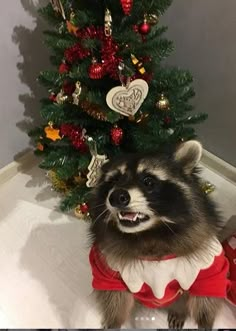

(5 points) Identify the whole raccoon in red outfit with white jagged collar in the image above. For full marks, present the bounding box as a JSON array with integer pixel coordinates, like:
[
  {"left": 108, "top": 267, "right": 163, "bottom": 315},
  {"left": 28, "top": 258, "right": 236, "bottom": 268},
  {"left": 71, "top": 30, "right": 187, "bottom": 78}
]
[{"left": 90, "top": 141, "right": 228, "bottom": 329}]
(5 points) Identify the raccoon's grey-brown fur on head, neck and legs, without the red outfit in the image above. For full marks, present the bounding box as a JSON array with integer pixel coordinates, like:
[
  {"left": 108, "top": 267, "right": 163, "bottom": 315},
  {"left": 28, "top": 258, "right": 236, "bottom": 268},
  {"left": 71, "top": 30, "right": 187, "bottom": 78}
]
[{"left": 90, "top": 141, "right": 225, "bottom": 328}]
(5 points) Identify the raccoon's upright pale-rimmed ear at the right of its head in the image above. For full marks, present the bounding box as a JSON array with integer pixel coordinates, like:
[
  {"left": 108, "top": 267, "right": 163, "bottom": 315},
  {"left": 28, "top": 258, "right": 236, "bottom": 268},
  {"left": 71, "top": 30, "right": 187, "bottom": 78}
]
[{"left": 174, "top": 140, "right": 202, "bottom": 174}]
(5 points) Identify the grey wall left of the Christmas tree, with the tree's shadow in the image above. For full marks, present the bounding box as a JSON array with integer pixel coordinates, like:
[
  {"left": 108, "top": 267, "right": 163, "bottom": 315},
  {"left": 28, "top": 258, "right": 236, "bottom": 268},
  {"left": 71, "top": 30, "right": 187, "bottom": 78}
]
[{"left": 0, "top": 0, "right": 48, "bottom": 168}]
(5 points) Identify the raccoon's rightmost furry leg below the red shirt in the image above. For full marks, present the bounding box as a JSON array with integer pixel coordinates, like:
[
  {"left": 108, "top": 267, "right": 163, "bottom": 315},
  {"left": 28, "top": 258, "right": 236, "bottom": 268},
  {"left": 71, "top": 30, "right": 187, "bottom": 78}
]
[{"left": 189, "top": 297, "right": 223, "bottom": 329}]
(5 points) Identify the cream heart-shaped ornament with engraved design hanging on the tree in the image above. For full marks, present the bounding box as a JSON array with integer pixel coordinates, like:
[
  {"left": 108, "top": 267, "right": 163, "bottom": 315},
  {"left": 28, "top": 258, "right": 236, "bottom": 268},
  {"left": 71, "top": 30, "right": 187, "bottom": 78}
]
[{"left": 106, "top": 79, "right": 149, "bottom": 116}]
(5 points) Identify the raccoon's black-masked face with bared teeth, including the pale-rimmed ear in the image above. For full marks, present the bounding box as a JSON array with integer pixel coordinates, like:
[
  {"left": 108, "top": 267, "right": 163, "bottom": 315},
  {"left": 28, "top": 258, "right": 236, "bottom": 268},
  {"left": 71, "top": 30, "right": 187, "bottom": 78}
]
[{"left": 91, "top": 141, "right": 202, "bottom": 233}]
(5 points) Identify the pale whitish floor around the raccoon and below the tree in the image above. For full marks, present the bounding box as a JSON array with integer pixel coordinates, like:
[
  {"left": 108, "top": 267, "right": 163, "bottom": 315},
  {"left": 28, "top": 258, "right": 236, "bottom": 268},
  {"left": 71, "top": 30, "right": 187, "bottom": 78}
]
[{"left": 0, "top": 158, "right": 236, "bottom": 329}]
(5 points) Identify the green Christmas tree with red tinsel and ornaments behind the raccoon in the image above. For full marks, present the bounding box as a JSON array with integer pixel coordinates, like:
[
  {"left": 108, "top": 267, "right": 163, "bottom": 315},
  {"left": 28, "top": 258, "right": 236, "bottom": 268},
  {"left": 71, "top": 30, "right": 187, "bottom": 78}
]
[{"left": 30, "top": 0, "right": 206, "bottom": 217}]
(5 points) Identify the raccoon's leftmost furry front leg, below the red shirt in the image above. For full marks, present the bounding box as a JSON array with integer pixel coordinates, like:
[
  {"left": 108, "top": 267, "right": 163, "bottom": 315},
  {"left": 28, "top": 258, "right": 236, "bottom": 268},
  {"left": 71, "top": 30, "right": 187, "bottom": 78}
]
[{"left": 95, "top": 291, "right": 134, "bottom": 329}]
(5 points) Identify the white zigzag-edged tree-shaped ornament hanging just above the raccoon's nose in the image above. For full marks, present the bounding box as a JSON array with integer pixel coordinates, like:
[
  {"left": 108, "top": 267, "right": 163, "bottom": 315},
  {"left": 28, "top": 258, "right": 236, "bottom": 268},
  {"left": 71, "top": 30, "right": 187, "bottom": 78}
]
[{"left": 86, "top": 154, "right": 108, "bottom": 187}]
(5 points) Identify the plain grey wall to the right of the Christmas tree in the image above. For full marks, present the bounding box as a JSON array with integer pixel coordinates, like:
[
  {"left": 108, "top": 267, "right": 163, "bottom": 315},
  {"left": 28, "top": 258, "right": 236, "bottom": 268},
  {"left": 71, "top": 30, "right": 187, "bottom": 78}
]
[{"left": 163, "top": 0, "right": 236, "bottom": 166}]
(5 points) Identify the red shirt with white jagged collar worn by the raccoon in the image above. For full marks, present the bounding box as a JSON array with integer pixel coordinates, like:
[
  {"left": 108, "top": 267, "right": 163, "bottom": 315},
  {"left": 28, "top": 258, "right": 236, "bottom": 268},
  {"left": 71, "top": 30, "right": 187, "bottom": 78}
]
[{"left": 90, "top": 241, "right": 236, "bottom": 308}]
